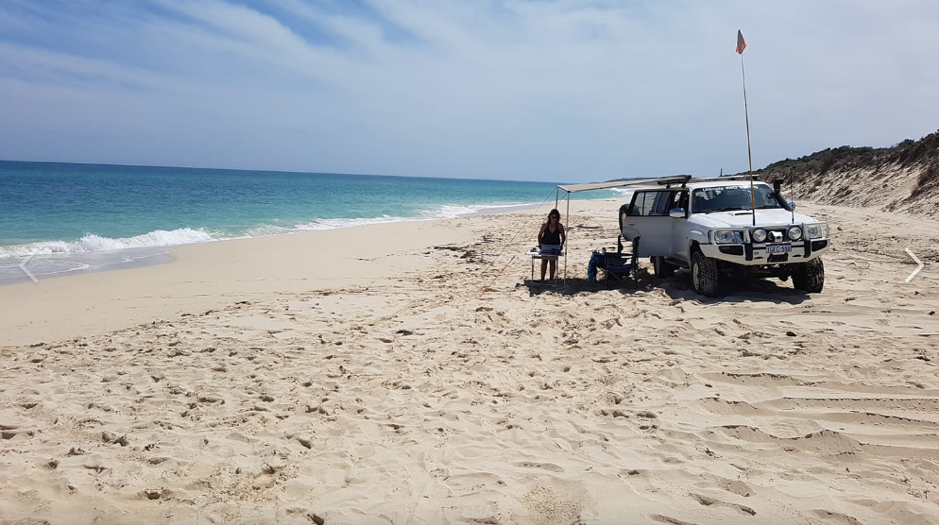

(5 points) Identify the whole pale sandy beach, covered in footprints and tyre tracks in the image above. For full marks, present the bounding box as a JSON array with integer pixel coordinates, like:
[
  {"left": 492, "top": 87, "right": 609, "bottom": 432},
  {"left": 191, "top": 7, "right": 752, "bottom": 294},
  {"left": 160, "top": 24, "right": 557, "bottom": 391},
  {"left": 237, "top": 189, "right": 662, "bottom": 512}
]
[{"left": 0, "top": 201, "right": 939, "bottom": 525}]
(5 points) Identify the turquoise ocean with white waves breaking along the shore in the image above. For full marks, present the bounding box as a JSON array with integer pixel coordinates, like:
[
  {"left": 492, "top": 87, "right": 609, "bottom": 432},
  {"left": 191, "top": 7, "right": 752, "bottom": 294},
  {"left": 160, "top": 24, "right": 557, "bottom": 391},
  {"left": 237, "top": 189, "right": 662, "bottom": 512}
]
[{"left": 0, "top": 161, "right": 618, "bottom": 285}]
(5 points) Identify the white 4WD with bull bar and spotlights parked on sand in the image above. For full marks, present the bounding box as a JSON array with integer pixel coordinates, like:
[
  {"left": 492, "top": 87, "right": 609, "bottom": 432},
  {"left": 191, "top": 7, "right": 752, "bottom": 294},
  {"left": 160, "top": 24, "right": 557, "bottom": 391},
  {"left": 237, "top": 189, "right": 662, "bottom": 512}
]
[{"left": 620, "top": 176, "right": 831, "bottom": 297}]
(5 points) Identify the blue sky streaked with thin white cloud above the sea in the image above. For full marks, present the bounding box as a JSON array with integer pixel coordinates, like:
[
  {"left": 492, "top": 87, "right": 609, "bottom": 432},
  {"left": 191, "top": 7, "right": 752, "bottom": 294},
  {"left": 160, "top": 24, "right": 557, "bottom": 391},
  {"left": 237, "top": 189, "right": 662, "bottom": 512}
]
[{"left": 0, "top": 0, "right": 939, "bottom": 182}]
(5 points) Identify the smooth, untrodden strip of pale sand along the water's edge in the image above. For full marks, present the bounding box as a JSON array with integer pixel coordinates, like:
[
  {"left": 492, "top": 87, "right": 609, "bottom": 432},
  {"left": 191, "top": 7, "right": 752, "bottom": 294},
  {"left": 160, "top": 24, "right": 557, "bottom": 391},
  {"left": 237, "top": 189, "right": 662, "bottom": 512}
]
[{"left": 0, "top": 205, "right": 560, "bottom": 348}]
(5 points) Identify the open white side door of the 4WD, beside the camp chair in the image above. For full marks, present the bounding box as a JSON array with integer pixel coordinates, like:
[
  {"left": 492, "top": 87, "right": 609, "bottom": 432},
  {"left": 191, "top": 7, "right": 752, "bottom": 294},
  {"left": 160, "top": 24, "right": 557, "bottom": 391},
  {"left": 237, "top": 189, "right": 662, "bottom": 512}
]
[{"left": 622, "top": 189, "right": 676, "bottom": 257}]
